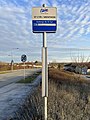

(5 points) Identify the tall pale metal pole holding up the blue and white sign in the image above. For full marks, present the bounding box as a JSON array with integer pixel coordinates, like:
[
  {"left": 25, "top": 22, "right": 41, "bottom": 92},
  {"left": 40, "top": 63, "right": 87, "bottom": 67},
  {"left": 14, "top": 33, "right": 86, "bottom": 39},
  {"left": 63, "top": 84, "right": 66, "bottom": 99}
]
[{"left": 42, "top": 32, "right": 48, "bottom": 120}]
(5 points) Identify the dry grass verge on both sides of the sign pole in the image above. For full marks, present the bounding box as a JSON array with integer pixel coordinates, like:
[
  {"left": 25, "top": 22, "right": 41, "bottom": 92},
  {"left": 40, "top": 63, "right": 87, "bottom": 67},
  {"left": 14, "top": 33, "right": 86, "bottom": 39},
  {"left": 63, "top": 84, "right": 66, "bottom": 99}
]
[{"left": 10, "top": 69, "right": 90, "bottom": 120}]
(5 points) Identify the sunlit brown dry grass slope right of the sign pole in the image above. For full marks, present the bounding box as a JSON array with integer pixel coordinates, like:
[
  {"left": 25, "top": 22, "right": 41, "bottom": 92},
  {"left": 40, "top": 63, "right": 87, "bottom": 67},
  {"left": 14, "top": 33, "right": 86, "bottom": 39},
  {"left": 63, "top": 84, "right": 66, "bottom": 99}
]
[{"left": 48, "top": 69, "right": 90, "bottom": 120}]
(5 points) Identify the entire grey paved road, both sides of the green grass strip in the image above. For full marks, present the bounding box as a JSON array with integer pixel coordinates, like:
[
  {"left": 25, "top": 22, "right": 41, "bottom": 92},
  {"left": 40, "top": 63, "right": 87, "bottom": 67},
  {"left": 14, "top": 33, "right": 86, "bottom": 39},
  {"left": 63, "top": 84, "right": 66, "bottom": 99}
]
[{"left": 0, "top": 69, "right": 41, "bottom": 120}]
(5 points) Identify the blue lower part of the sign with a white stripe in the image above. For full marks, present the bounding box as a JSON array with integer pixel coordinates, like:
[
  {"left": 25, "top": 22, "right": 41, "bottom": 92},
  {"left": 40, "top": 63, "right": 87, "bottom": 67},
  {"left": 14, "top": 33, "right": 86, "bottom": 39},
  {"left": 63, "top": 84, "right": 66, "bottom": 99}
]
[{"left": 32, "top": 20, "right": 57, "bottom": 32}]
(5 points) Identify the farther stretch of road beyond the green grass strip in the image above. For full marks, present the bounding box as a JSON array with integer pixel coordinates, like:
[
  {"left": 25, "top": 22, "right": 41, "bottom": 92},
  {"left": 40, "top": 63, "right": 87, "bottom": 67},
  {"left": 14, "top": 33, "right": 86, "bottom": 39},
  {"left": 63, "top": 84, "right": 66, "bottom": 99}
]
[{"left": 0, "top": 69, "right": 40, "bottom": 88}]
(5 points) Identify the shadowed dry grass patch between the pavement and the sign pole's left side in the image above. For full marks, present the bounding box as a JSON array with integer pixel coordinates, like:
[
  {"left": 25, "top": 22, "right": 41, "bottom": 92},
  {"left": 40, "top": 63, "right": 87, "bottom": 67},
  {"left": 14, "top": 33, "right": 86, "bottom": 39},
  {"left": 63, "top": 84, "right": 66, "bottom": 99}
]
[{"left": 8, "top": 88, "right": 43, "bottom": 120}]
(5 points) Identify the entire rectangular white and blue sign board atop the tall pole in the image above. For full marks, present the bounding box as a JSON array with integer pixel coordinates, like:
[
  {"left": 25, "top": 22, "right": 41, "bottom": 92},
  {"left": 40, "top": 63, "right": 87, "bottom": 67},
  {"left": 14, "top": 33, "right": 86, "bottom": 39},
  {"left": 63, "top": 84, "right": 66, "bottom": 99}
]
[{"left": 32, "top": 7, "right": 57, "bottom": 32}]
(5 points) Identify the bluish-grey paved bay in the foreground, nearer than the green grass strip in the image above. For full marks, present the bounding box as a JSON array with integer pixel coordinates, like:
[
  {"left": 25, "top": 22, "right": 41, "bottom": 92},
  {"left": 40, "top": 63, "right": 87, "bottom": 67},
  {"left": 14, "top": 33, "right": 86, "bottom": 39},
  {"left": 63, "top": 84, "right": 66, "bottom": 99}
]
[{"left": 0, "top": 72, "right": 41, "bottom": 120}]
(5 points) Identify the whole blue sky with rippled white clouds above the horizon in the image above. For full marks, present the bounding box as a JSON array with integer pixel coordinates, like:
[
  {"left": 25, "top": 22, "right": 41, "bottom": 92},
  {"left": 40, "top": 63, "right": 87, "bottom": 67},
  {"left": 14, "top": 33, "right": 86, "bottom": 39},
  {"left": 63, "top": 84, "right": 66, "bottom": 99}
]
[{"left": 0, "top": 0, "right": 90, "bottom": 62}]
